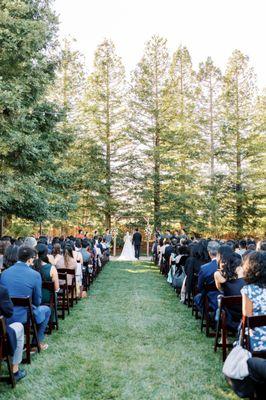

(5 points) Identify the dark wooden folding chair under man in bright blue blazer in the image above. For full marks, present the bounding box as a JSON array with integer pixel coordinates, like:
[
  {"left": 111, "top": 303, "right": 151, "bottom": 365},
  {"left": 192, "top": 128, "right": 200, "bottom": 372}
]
[{"left": 11, "top": 297, "right": 41, "bottom": 364}]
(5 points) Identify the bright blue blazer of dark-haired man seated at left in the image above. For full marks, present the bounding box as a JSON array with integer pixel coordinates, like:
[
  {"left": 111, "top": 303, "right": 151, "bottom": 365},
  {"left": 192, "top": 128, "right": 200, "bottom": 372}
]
[{"left": 1, "top": 261, "right": 45, "bottom": 324}]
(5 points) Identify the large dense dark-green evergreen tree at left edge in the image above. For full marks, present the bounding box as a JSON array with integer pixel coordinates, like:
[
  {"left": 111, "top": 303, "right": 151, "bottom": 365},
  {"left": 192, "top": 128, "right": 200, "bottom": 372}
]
[{"left": 0, "top": 0, "right": 77, "bottom": 227}]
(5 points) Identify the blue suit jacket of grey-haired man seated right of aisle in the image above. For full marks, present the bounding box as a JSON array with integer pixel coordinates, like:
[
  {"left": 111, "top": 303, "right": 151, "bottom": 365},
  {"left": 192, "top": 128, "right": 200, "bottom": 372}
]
[{"left": 198, "top": 259, "right": 220, "bottom": 309}]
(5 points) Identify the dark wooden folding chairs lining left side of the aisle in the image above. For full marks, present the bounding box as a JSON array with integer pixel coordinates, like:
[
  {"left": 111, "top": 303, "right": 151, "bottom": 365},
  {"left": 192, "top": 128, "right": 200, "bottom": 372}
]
[{"left": 0, "top": 256, "right": 109, "bottom": 388}]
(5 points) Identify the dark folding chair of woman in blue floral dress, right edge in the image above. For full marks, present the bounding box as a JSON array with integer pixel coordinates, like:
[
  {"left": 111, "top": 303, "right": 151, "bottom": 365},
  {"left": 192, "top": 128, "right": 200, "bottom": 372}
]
[{"left": 242, "top": 314, "right": 266, "bottom": 358}]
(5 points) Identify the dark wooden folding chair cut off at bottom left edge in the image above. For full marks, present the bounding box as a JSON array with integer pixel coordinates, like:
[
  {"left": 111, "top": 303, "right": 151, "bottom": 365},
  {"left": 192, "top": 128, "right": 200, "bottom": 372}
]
[{"left": 0, "top": 316, "right": 16, "bottom": 388}]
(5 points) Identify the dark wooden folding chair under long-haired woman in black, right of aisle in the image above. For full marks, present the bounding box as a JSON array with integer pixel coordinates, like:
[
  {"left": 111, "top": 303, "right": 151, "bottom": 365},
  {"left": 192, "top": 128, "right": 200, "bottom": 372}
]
[{"left": 214, "top": 295, "right": 242, "bottom": 361}]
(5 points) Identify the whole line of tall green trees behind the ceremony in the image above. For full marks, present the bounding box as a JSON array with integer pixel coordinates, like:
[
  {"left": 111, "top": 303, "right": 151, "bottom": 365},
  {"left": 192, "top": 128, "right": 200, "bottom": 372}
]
[{"left": 0, "top": 0, "right": 266, "bottom": 237}]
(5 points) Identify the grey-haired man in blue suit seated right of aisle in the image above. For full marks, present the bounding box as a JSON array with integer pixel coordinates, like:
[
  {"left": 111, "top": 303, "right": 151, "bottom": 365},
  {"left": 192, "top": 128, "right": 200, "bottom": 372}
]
[{"left": 194, "top": 240, "right": 220, "bottom": 310}]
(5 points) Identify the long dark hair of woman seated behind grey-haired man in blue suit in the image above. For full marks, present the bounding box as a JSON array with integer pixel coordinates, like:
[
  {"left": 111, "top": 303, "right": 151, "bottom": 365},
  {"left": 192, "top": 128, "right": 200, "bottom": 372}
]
[{"left": 218, "top": 245, "right": 241, "bottom": 281}]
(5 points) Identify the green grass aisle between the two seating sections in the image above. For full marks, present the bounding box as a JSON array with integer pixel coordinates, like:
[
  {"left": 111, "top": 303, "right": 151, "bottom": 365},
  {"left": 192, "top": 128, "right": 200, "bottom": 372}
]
[{"left": 0, "top": 262, "right": 236, "bottom": 400}]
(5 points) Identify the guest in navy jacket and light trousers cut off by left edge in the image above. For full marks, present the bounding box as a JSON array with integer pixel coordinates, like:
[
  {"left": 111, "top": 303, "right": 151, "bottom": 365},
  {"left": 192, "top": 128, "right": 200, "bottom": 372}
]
[{"left": 0, "top": 285, "right": 26, "bottom": 382}]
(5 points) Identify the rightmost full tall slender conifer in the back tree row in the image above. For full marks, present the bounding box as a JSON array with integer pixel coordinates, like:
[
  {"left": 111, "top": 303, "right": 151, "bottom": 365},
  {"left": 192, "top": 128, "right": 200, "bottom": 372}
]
[{"left": 219, "top": 50, "right": 259, "bottom": 236}]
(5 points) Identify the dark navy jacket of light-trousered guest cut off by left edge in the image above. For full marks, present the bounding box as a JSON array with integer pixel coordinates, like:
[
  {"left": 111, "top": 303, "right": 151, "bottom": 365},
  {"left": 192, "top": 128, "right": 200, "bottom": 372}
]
[{"left": 0, "top": 285, "right": 17, "bottom": 356}]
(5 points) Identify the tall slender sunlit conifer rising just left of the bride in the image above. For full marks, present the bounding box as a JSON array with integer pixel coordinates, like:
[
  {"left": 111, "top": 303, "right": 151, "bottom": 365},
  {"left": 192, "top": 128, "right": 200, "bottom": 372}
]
[{"left": 81, "top": 40, "right": 128, "bottom": 227}]
